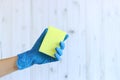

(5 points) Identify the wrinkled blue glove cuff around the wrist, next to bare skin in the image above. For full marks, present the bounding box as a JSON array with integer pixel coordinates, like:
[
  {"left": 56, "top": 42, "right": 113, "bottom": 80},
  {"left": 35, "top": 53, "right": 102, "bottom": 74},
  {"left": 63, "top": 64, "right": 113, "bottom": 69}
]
[{"left": 16, "top": 51, "right": 33, "bottom": 70}]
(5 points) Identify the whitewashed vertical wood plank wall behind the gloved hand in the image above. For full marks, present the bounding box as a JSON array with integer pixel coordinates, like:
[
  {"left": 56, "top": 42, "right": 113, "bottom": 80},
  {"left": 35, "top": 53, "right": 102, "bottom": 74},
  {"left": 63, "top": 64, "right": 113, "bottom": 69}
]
[{"left": 0, "top": 0, "right": 120, "bottom": 80}]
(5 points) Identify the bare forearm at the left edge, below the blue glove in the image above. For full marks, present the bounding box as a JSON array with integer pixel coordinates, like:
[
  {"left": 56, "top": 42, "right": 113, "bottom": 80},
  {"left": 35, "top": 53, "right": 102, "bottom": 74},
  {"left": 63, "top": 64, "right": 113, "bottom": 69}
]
[{"left": 0, "top": 56, "right": 17, "bottom": 77}]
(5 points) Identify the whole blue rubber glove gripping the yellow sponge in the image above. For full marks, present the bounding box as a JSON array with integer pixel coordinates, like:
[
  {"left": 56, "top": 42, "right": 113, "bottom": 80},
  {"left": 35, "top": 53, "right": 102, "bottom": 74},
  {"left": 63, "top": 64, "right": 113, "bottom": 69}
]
[{"left": 16, "top": 29, "right": 68, "bottom": 70}]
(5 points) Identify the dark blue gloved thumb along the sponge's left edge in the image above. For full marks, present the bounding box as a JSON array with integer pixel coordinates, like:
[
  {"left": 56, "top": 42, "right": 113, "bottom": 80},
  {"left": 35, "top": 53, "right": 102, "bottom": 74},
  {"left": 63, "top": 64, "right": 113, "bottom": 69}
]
[{"left": 32, "top": 28, "right": 48, "bottom": 49}]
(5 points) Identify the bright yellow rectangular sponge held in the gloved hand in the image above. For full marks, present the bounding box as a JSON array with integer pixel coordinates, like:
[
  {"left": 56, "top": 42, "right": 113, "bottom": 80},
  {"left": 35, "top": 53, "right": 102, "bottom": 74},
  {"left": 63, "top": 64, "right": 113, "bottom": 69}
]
[{"left": 39, "top": 26, "right": 66, "bottom": 58}]
